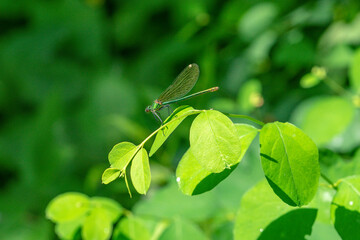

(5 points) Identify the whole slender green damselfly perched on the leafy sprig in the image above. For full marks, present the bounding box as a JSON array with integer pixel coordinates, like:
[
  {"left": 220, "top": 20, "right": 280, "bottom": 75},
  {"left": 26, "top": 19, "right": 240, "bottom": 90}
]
[{"left": 145, "top": 63, "right": 219, "bottom": 124}]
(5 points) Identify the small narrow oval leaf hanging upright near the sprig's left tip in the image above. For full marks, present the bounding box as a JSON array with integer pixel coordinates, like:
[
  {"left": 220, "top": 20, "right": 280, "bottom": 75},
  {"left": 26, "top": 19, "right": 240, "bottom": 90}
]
[{"left": 130, "top": 148, "right": 151, "bottom": 194}]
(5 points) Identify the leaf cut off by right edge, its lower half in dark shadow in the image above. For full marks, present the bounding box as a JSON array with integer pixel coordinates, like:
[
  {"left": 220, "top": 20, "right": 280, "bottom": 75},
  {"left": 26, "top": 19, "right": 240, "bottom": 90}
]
[{"left": 331, "top": 175, "right": 360, "bottom": 240}]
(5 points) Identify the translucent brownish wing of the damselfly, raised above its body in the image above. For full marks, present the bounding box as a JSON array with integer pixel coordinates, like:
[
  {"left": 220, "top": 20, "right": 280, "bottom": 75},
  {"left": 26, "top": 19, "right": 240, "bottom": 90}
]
[{"left": 158, "top": 63, "right": 200, "bottom": 102}]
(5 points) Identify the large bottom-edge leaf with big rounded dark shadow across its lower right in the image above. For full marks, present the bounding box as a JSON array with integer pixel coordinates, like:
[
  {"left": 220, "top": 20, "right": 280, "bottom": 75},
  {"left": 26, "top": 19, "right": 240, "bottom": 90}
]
[{"left": 234, "top": 181, "right": 316, "bottom": 240}]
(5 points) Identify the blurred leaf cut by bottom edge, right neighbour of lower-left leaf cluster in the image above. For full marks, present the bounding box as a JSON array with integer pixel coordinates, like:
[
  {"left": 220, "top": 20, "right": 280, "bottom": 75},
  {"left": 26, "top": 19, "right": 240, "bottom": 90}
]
[{"left": 112, "top": 216, "right": 151, "bottom": 240}]
